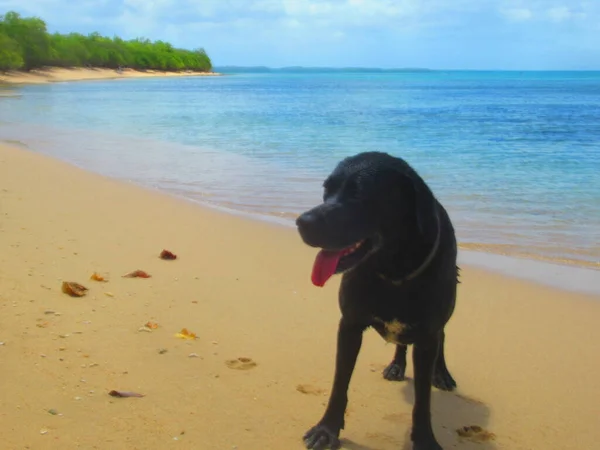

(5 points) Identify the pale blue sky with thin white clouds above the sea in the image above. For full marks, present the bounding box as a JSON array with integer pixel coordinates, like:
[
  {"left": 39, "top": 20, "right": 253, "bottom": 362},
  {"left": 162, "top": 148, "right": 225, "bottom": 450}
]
[{"left": 0, "top": 0, "right": 600, "bottom": 70}]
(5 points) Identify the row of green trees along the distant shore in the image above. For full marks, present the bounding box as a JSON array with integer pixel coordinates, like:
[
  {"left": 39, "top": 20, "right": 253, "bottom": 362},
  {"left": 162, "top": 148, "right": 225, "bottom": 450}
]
[{"left": 0, "top": 12, "right": 212, "bottom": 72}]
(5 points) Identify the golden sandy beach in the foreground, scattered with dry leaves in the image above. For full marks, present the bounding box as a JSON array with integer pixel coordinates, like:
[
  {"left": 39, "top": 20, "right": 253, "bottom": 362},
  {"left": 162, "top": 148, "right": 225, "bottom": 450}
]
[{"left": 0, "top": 146, "right": 600, "bottom": 450}]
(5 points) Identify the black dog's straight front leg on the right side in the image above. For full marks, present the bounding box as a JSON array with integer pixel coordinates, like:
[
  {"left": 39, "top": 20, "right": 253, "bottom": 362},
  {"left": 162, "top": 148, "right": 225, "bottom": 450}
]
[{"left": 410, "top": 336, "right": 442, "bottom": 450}]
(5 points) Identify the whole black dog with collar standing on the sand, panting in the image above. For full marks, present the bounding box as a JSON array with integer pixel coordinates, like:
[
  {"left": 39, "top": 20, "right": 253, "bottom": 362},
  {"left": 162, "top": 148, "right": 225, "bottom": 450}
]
[{"left": 296, "top": 152, "right": 459, "bottom": 450}]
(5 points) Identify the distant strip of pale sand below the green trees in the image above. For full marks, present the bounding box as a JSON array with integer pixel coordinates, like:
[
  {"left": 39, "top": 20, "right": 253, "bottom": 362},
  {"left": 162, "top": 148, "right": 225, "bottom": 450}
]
[{"left": 0, "top": 67, "right": 224, "bottom": 86}]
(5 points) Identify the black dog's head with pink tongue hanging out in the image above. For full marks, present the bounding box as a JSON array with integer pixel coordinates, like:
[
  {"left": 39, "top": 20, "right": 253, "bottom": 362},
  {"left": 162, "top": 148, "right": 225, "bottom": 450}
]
[{"left": 296, "top": 152, "right": 437, "bottom": 286}]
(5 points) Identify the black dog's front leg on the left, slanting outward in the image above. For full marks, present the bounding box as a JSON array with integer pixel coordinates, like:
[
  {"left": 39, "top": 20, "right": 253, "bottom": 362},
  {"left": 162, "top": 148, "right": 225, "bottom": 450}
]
[{"left": 304, "top": 317, "right": 365, "bottom": 450}]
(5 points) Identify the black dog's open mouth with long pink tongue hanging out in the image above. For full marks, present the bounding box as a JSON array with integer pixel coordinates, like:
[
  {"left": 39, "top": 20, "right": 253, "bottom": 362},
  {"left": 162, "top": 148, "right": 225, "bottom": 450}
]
[{"left": 311, "top": 239, "right": 371, "bottom": 287}]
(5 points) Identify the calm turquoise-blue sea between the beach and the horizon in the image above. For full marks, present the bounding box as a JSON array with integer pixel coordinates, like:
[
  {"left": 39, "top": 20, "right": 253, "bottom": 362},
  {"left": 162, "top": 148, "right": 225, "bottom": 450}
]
[{"left": 0, "top": 69, "right": 600, "bottom": 267}]
